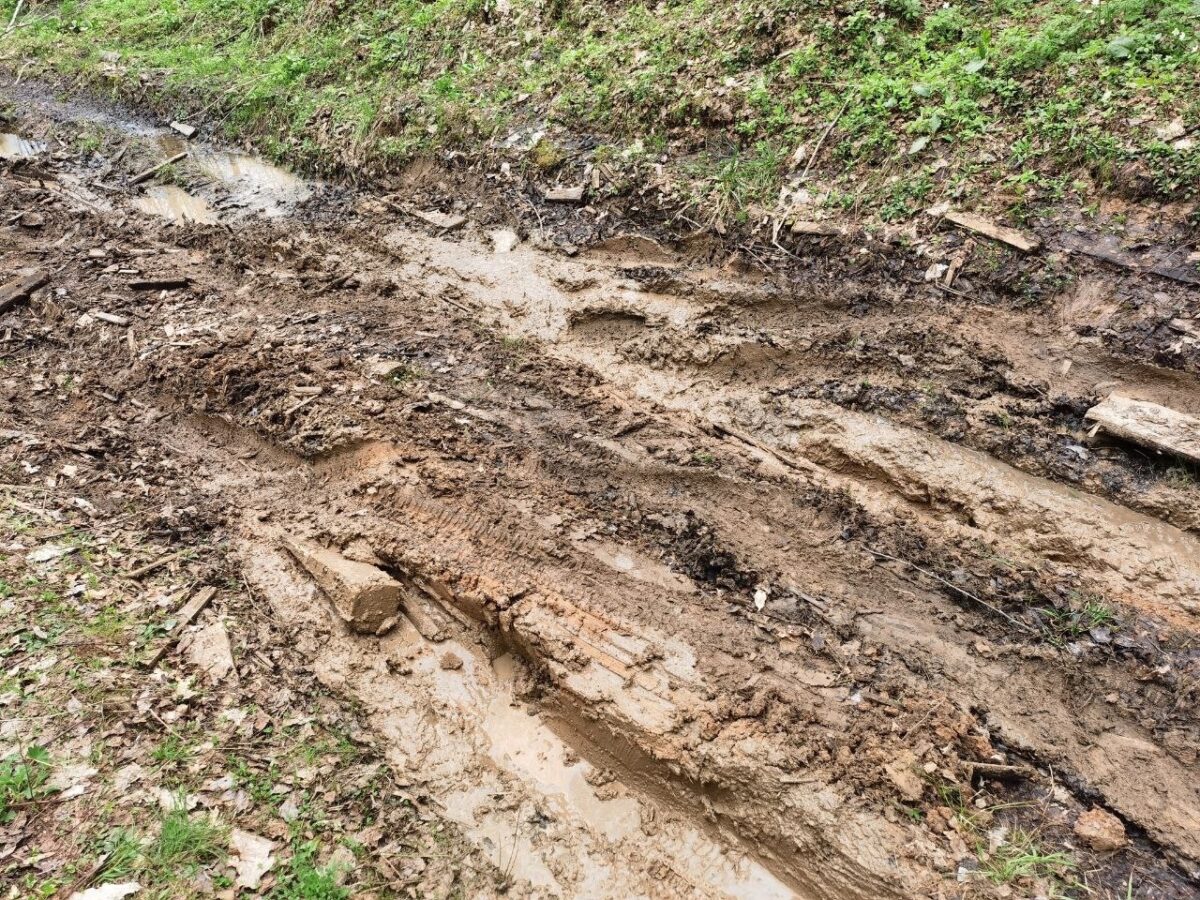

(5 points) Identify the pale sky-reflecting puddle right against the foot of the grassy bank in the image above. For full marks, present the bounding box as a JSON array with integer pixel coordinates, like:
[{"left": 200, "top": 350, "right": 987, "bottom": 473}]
[{"left": 157, "top": 134, "right": 312, "bottom": 217}]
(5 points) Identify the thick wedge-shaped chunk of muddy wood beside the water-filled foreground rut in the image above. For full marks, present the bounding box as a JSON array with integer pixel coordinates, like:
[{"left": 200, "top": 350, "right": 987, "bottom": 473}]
[{"left": 282, "top": 536, "right": 403, "bottom": 634}]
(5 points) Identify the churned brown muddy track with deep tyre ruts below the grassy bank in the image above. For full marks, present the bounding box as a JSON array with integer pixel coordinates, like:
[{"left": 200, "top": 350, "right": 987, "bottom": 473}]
[{"left": 0, "top": 79, "right": 1200, "bottom": 898}]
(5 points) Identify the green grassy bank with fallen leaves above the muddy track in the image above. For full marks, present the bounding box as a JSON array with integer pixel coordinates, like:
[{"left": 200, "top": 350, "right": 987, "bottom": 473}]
[{"left": 0, "top": 0, "right": 1200, "bottom": 221}]
